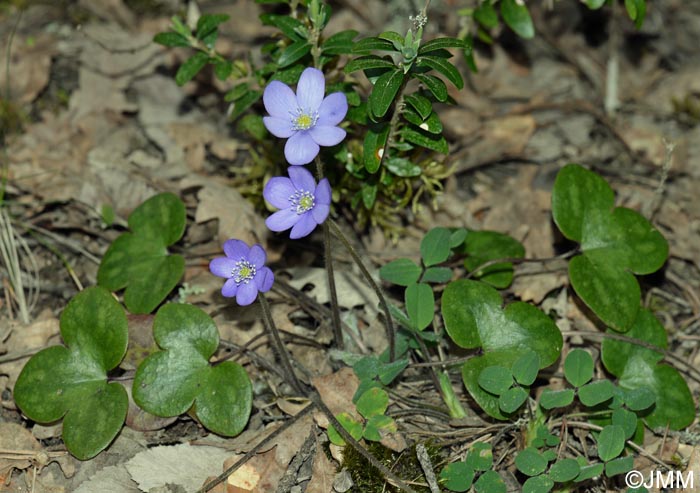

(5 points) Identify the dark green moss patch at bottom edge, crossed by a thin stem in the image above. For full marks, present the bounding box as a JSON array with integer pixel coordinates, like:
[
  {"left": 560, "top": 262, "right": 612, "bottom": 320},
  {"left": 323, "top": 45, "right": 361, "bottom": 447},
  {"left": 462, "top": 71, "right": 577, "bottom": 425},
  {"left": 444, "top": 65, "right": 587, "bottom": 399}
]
[{"left": 341, "top": 442, "right": 441, "bottom": 493}]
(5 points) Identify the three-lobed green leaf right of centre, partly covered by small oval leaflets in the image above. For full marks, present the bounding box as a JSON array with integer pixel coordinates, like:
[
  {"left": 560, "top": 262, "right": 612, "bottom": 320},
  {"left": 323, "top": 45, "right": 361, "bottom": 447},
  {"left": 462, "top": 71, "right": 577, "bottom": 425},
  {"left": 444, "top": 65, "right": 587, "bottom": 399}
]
[{"left": 442, "top": 280, "right": 562, "bottom": 419}]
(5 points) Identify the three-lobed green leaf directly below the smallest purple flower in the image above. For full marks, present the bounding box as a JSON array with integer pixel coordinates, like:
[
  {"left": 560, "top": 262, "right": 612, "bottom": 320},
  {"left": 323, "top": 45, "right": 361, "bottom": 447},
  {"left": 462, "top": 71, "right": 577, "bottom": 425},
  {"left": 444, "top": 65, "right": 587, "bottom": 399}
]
[{"left": 133, "top": 303, "right": 253, "bottom": 436}]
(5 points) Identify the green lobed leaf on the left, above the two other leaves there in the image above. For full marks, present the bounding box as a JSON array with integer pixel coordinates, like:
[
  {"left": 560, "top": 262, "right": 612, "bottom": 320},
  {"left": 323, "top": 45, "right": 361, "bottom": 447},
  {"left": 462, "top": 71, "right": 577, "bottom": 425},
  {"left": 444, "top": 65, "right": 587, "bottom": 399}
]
[{"left": 97, "top": 193, "right": 185, "bottom": 313}]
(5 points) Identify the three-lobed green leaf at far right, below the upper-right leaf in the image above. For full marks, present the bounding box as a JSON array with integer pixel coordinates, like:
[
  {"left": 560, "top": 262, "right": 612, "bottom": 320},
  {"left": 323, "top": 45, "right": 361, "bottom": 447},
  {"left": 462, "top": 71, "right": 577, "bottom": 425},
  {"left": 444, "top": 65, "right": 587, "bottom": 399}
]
[{"left": 601, "top": 309, "right": 695, "bottom": 430}]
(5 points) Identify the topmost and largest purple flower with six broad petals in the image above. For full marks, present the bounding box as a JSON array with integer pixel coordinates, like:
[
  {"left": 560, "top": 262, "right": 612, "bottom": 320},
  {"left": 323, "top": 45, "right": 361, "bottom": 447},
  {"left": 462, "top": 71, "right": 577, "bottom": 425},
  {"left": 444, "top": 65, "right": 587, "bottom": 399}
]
[{"left": 263, "top": 68, "right": 348, "bottom": 165}]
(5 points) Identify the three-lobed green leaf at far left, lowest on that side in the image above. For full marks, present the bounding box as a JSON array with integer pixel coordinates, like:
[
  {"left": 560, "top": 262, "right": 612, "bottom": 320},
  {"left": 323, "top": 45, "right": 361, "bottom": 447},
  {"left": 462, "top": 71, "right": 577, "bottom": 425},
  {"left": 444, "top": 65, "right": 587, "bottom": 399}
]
[{"left": 14, "top": 287, "right": 128, "bottom": 460}]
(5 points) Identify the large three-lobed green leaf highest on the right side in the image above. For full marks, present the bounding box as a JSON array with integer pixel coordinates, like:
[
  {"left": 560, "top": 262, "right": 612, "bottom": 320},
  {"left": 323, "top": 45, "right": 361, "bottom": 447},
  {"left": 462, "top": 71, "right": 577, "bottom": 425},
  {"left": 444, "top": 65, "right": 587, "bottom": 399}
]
[{"left": 552, "top": 164, "right": 668, "bottom": 332}]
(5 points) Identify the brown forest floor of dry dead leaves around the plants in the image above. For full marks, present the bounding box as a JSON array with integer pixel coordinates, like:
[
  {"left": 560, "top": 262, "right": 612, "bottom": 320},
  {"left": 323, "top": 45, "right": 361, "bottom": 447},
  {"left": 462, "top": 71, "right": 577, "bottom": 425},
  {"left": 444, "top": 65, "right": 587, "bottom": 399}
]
[{"left": 0, "top": 0, "right": 700, "bottom": 493}]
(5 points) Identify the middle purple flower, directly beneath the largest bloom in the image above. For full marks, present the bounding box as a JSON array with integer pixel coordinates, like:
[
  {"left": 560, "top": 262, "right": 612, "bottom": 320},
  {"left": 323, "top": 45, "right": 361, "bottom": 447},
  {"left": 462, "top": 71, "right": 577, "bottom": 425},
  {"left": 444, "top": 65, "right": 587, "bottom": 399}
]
[{"left": 263, "top": 166, "right": 331, "bottom": 240}]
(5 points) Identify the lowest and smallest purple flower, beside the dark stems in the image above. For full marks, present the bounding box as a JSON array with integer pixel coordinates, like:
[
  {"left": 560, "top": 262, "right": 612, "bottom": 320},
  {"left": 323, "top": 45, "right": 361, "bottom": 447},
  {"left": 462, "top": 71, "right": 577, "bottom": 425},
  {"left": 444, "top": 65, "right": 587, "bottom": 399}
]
[{"left": 209, "top": 240, "right": 275, "bottom": 306}]
